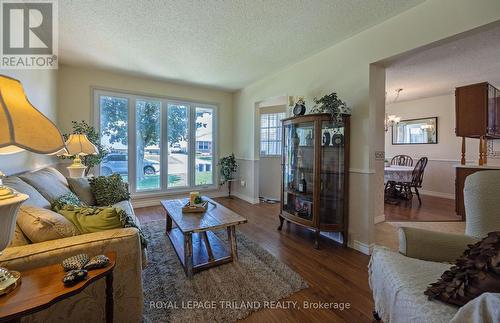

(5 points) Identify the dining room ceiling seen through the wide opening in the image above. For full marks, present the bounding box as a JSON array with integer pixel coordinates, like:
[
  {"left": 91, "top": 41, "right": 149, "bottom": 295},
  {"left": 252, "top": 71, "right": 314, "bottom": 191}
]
[{"left": 386, "top": 24, "right": 500, "bottom": 103}]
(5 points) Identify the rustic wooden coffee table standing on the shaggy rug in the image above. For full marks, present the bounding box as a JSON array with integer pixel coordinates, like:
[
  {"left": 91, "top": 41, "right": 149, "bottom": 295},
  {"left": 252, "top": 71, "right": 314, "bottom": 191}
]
[{"left": 161, "top": 197, "right": 247, "bottom": 277}]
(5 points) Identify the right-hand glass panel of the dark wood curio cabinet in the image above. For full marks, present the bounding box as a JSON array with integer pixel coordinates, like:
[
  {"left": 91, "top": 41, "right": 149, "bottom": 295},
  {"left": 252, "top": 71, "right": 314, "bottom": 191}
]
[{"left": 319, "top": 121, "right": 345, "bottom": 224}]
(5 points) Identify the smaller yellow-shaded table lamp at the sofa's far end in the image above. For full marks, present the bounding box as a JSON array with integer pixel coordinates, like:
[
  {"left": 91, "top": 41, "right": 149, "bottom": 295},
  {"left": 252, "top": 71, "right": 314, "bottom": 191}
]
[{"left": 62, "top": 134, "right": 98, "bottom": 178}]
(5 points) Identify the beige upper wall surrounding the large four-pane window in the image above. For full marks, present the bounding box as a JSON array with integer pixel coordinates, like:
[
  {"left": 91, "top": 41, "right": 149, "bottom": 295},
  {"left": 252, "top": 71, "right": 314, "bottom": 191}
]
[{"left": 58, "top": 65, "right": 233, "bottom": 156}]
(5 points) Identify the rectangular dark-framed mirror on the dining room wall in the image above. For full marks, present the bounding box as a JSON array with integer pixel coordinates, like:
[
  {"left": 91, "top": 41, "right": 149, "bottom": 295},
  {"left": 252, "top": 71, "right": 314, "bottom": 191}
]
[{"left": 392, "top": 117, "right": 437, "bottom": 145}]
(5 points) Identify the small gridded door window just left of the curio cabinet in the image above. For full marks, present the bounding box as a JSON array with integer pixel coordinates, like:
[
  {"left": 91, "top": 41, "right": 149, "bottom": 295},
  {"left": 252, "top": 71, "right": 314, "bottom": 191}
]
[{"left": 260, "top": 112, "right": 285, "bottom": 156}]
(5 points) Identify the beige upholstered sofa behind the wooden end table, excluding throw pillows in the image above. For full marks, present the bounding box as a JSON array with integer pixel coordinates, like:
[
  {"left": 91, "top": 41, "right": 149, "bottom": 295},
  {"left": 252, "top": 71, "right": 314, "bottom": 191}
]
[{"left": 0, "top": 168, "right": 146, "bottom": 322}]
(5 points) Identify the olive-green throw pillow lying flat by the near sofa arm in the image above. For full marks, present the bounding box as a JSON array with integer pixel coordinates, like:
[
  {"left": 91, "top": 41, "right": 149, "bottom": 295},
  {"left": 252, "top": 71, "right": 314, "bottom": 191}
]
[{"left": 57, "top": 205, "right": 147, "bottom": 248}]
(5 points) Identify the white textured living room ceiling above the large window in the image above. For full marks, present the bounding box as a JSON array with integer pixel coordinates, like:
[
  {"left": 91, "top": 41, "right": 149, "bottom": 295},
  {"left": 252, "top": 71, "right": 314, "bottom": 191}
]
[{"left": 59, "top": 0, "right": 423, "bottom": 90}]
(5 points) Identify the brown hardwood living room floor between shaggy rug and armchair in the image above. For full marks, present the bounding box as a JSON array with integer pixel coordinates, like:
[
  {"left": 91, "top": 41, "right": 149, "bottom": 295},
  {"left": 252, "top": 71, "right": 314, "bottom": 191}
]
[{"left": 136, "top": 198, "right": 373, "bottom": 323}]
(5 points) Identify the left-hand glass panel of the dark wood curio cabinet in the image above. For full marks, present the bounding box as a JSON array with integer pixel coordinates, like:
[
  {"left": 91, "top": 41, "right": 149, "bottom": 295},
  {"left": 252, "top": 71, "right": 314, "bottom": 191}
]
[{"left": 283, "top": 122, "right": 314, "bottom": 220}]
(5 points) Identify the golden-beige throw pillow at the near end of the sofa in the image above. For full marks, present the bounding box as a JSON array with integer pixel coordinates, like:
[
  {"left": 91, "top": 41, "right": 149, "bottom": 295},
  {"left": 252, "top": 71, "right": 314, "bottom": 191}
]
[{"left": 17, "top": 206, "right": 80, "bottom": 243}]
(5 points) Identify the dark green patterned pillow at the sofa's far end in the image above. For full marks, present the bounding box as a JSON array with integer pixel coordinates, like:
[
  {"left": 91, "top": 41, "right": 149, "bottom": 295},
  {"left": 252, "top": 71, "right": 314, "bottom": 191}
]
[{"left": 89, "top": 174, "right": 130, "bottom": 206}]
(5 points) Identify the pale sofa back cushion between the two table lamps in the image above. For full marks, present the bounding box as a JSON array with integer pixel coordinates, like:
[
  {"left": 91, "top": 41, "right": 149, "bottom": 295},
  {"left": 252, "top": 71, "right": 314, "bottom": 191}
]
[{"left": 19, "top": 167, "right": 71, "bottom": 203}]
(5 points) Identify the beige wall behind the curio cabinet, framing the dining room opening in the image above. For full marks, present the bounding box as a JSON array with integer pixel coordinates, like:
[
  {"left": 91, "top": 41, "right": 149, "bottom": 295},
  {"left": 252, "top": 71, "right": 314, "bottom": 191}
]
[{"left": 234, "top": 0, "right": 500, "bottom": 250}]
